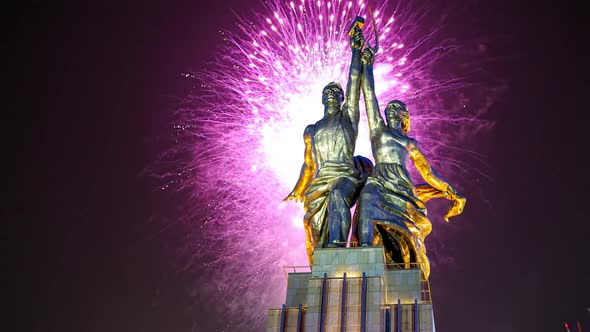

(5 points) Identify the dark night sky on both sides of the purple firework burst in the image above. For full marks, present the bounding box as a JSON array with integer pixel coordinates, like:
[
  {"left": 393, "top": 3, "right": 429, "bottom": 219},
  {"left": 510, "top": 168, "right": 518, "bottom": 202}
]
[{"left": 13, "top": 0, "right": 590, "bottom": 332}]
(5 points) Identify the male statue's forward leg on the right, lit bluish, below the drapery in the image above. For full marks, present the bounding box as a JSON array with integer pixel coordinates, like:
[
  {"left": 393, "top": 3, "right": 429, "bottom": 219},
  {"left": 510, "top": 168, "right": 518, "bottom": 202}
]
[{"left": 327, "top": 178, "right": 358, "bottom": 247}]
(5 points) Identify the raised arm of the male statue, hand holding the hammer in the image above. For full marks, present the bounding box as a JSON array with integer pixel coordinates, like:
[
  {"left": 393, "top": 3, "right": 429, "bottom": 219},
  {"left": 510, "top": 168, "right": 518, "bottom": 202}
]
[{"left": 344, "top": 27, "right": 365, "bottom": 134}]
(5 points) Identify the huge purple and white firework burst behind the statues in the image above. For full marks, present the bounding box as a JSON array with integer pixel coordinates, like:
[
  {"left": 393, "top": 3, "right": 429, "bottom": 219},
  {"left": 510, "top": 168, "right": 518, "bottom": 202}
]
[{"left": 156, "top": 0, "right": 500, "bottom": 330}]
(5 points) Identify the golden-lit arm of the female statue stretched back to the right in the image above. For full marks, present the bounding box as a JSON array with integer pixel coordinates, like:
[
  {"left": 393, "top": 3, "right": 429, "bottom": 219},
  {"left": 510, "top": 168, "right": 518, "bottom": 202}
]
[{"left": 408, "top": 140, "right": 467, "bottom": 222}]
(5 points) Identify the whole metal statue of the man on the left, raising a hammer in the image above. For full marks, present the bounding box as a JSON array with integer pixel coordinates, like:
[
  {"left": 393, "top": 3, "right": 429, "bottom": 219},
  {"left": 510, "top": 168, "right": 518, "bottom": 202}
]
[{"left": 285, "top": 24, "right": 364, "bottom": 264}]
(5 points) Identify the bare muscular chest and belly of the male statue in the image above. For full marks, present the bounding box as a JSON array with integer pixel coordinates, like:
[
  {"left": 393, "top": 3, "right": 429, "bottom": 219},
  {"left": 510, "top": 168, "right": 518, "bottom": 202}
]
[{"left": 312, "top": 112, "right": 356, "bottom": 169}]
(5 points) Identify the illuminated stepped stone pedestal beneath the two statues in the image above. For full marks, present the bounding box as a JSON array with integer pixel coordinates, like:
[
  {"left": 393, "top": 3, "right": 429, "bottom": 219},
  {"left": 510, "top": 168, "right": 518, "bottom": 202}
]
[{"left": 266, "top": 247, "right": 435, "bottom": 332}]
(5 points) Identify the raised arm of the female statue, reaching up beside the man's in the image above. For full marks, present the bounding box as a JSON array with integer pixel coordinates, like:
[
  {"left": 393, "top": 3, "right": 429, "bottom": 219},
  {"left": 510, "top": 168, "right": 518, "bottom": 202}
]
[{"left": 361, "top": 47, "right": 385, "bottom": 139}]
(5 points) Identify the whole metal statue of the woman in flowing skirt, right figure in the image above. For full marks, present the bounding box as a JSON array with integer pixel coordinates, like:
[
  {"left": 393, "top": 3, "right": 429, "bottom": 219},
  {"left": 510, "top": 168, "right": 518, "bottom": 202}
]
[{"left": 358, "top": 47, "right": 466, "bottom": 278}]
